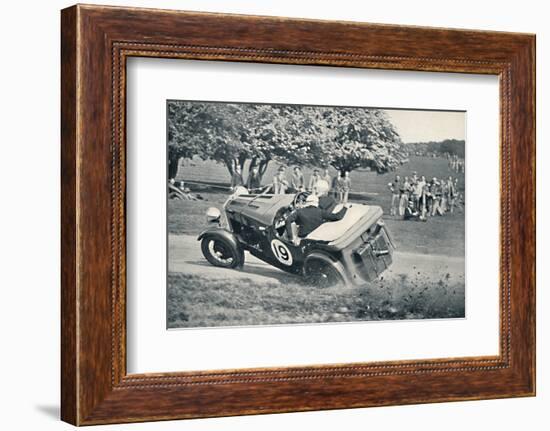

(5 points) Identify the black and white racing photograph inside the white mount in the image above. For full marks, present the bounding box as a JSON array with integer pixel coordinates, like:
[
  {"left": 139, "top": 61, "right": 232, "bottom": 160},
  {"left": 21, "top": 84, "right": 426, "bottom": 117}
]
[{"left": 166, "top": 100, "right": 466, "bottom": 329}]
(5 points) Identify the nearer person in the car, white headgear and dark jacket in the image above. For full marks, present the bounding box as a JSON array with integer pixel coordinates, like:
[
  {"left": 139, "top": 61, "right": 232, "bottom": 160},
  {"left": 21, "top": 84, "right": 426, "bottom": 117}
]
[{"left": 286, "top": 195, "right": 347, "bottom": 245}]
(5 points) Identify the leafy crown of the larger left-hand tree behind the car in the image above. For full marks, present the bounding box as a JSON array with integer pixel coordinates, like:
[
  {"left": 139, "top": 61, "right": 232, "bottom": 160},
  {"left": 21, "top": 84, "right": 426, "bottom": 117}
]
[{"left": 168, "top": 101, "right": 334, "bottom": 181}]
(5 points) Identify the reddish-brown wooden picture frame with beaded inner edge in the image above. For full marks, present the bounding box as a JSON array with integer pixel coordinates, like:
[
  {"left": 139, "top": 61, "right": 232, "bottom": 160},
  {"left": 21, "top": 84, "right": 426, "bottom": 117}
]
[{"left": 61, "top": 5, "right": 535, "bottom": 425}]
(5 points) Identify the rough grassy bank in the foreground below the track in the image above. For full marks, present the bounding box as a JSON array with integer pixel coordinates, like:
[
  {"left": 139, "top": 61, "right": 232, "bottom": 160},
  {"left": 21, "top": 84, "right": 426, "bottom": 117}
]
[{"left": 167, "top": 273, "right": 464, "bottom": 328}]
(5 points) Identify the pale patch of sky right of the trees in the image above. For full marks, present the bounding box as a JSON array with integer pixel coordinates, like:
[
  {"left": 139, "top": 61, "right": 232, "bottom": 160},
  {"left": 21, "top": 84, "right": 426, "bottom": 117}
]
[{"left": 384, "top": 109, "right": 466, "bottom": 143}]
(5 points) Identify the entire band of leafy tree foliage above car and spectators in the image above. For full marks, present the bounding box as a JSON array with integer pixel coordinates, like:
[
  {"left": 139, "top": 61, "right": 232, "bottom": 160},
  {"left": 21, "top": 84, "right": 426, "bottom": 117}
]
[{"left": 168, "top": 101, "right": 402, "bottom": 179}]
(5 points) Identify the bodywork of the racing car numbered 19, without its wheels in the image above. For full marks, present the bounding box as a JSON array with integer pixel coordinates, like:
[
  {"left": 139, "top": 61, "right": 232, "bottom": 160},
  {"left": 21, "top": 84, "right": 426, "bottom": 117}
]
[{"left": 199, "top": 194, "right": 393, "bottom": 284}]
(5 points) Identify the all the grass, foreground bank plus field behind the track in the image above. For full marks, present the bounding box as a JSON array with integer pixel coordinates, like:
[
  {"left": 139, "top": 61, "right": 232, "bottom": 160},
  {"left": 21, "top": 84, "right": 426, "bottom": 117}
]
[{"left": 168, "top": 157, "right": 465, "bottom": 327}]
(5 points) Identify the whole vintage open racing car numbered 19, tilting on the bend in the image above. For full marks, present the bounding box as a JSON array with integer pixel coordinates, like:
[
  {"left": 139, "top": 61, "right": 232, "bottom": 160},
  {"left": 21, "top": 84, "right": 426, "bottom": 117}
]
[{"left": 198, "top": 189, "right": 393, "bottom": 286}]
